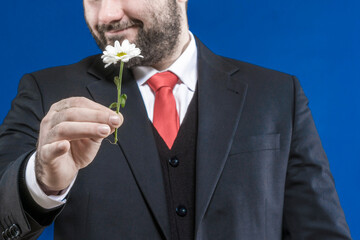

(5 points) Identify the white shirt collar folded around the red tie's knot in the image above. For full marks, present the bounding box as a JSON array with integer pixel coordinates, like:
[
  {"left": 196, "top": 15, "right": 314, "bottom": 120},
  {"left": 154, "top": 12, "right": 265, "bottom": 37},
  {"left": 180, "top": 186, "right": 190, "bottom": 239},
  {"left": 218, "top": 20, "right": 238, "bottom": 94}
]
[{"left": 132, "top": 31, "right": 197, "bottom": 91}]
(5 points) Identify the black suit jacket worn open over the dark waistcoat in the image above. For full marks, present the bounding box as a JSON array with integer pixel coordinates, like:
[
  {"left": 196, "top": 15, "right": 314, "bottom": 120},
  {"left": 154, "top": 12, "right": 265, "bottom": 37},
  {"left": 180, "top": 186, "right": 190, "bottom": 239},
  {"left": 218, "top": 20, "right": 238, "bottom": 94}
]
[{"left": 0, "top": 40, "right": 351, "bottom": 240}]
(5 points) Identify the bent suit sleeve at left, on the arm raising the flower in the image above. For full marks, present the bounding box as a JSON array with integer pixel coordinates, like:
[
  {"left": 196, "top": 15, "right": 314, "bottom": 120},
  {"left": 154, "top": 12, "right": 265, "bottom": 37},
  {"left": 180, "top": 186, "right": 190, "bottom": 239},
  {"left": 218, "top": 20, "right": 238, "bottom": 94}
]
[{"left": 0, "top": 75, "right": 62, "bottom": 239}]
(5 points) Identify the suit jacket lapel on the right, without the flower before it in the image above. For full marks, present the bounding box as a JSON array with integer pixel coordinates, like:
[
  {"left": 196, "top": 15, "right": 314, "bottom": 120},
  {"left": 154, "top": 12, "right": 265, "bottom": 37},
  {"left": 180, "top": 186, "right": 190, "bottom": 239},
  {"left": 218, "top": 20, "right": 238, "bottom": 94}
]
[{"left": 195, "top": 40, "right": 247, "bottom": 234}]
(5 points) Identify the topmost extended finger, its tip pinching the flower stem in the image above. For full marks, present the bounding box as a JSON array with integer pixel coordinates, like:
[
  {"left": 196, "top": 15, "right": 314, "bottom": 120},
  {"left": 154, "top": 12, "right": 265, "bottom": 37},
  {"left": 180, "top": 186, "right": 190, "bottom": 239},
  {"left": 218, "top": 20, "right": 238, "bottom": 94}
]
[{"left": 49, "top": 107, "right": 123, "bottom": 128}]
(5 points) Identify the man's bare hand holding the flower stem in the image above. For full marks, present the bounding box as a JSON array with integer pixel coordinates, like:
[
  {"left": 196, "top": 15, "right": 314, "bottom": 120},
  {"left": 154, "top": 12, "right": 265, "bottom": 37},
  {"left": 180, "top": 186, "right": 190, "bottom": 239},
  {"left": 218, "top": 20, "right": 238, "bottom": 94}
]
[{"left": 35, "top": 97, "right": 123, "bottom": 195}]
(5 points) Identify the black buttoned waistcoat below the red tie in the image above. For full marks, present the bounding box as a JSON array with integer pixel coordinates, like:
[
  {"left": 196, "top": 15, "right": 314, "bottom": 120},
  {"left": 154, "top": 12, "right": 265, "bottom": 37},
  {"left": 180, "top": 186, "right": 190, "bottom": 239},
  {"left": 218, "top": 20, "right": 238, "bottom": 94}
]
[{"left": 153, "top": 92, "right": 198, "bottom": 240}]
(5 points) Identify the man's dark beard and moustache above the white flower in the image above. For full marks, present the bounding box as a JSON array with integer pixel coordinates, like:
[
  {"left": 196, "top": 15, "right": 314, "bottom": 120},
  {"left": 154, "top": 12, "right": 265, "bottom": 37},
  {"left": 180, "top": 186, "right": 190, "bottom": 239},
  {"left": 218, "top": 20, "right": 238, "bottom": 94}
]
[{"left": 88, "top": 0, "right": 181, "bottom": 68}]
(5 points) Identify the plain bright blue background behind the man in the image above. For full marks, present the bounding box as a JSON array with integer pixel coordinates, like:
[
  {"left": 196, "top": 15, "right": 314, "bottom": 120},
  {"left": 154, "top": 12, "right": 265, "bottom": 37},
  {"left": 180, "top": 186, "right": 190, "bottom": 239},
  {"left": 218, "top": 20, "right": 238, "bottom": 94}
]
[{"left": 0, "top": 0, "right": 360, "bottom": 240}]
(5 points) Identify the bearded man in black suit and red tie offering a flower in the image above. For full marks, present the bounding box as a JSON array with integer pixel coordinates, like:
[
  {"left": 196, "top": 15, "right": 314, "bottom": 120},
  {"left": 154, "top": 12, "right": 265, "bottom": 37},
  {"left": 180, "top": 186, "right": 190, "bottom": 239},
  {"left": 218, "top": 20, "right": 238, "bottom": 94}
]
[{"left": 0, "top": 0, "right": 351, "bottom": 240}]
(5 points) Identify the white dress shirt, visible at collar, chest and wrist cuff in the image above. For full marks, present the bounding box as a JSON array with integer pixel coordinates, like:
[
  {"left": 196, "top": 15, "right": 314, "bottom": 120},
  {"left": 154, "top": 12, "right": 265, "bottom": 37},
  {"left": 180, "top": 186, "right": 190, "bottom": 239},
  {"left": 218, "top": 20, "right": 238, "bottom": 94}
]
[{"left": 25, "top": 32, "right": 198, "bottom": 209}]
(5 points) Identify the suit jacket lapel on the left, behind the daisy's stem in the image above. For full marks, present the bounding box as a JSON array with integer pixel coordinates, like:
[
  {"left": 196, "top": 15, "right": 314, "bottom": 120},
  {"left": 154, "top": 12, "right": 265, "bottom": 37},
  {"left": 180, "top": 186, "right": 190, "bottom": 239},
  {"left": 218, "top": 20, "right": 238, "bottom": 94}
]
[{"left": 87, "top": 57, "right": 170, "bottom": 238}]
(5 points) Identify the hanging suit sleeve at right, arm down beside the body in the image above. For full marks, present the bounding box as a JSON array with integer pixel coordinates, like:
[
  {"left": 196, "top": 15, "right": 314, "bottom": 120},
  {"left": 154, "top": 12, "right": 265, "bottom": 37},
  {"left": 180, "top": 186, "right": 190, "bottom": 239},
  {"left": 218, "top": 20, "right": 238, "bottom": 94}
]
[{"left": 284, "top": 78, "right": 351, "bottom": 240}]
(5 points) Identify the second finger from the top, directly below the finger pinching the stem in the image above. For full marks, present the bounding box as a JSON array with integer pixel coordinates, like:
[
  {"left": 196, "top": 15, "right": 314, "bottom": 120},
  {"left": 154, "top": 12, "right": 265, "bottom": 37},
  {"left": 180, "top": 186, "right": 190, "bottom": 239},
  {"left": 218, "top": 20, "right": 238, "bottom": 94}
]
[{"left": 46, "top": 122, "right": 112, "bottom": 143}]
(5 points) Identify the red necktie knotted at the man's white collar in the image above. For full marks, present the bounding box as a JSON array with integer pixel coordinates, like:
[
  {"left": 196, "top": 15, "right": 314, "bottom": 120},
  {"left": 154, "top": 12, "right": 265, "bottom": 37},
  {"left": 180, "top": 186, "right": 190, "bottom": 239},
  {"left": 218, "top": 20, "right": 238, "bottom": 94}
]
[{"left": 147, "top": 71, "right": 180, "bottom": 149}]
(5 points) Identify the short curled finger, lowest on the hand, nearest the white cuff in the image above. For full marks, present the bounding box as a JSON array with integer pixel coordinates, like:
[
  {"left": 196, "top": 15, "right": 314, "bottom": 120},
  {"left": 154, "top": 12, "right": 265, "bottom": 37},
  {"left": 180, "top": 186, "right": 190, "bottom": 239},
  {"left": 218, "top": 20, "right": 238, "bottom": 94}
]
[{"left": 39, "top": 140, "right": 70, "bottom": 160}]
